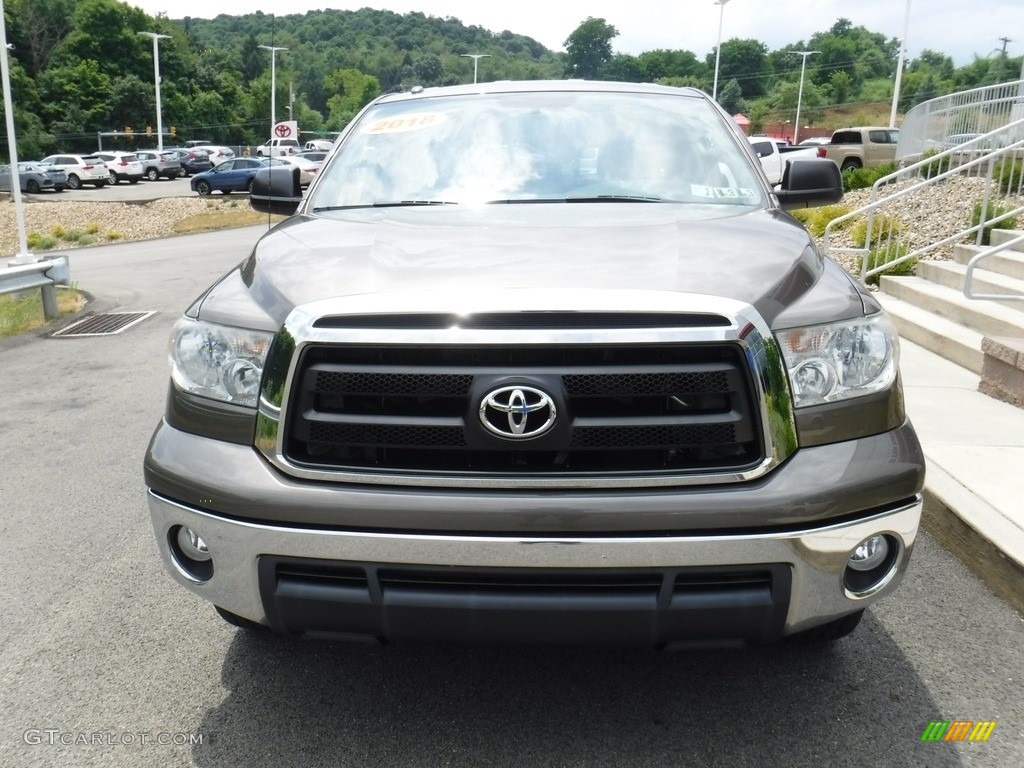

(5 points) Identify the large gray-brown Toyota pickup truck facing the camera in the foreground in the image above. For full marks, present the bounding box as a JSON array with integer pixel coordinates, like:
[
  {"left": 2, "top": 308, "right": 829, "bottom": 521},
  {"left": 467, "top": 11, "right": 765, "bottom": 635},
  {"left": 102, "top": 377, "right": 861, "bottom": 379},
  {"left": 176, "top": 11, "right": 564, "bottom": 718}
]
[{"left": 144, "top": 81, "right": 925, "bottom": 647}]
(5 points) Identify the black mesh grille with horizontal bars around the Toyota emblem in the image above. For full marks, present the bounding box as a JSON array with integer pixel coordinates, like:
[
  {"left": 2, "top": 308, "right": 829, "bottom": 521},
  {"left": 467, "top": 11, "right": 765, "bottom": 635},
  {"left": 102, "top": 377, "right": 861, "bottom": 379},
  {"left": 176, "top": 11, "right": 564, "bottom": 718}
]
[{"left": 284, "top": 342, "right": 764, "bottom": 476}]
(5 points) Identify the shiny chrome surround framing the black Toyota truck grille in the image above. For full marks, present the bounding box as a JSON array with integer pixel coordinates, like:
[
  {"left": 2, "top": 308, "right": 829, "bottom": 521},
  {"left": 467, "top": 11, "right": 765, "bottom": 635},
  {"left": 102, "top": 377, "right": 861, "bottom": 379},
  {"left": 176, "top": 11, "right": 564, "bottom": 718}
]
[{"left": 255, "top": 290, "right": 797, "bottom": 488}]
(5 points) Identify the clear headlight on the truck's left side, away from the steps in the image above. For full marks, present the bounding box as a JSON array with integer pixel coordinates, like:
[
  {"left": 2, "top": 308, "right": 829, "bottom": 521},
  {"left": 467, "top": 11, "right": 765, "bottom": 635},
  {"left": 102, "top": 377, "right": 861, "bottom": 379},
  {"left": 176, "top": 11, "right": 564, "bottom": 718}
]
[{"left": 170, "top": 317, "right": 273, "bottom": 408}]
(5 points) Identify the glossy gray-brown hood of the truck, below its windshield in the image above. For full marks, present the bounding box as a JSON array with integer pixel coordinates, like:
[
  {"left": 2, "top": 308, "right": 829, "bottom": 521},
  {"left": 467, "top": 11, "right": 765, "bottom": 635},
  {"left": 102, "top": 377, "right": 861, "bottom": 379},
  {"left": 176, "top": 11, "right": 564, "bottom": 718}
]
[{"left": 200, "top": 203, "right": 863, "bottom": 327}]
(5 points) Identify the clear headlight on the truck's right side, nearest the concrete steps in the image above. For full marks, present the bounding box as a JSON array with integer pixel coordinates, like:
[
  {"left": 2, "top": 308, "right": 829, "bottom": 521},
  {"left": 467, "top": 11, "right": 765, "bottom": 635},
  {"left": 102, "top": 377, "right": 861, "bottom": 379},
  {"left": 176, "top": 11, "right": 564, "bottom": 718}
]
[{"left": 775, "top": 313, "right": 899, "bottom": 408}]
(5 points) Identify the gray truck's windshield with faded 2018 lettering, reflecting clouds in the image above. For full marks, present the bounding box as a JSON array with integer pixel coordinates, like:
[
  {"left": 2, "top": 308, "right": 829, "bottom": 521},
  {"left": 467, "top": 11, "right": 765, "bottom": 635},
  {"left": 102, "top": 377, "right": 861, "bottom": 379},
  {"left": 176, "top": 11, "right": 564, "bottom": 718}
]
[{"left": 310, "top": 92, "right": 763, "bottom": 212}]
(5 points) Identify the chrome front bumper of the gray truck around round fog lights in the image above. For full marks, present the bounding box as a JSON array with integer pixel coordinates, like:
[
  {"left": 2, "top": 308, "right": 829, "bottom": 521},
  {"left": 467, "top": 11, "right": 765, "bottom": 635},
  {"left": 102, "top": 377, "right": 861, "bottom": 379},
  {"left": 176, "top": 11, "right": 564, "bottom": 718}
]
[{"left": 147, "top": 492, "right": 922, "bottom": 635}]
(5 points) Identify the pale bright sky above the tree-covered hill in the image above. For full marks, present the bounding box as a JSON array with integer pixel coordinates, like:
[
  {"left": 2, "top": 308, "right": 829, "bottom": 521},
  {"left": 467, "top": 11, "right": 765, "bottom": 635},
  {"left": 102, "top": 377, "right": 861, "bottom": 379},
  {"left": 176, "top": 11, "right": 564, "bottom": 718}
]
[{"left": 127, "top": 0, "right": 1024, "bottom": 67}]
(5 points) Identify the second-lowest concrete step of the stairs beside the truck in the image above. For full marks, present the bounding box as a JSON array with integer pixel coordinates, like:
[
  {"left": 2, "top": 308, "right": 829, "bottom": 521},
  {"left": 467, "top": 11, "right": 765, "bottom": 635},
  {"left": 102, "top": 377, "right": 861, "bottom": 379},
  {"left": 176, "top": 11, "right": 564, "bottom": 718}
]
[{"left": 879, "top": 275, "right": 1024, "bottom": 337}]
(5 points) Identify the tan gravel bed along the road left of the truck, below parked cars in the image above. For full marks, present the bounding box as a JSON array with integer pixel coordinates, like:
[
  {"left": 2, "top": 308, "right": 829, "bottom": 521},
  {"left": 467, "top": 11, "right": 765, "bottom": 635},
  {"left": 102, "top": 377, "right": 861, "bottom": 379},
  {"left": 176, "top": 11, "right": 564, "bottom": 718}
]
[{"left": 0, "top": 197, "right": 249, "bottom": 256}]
